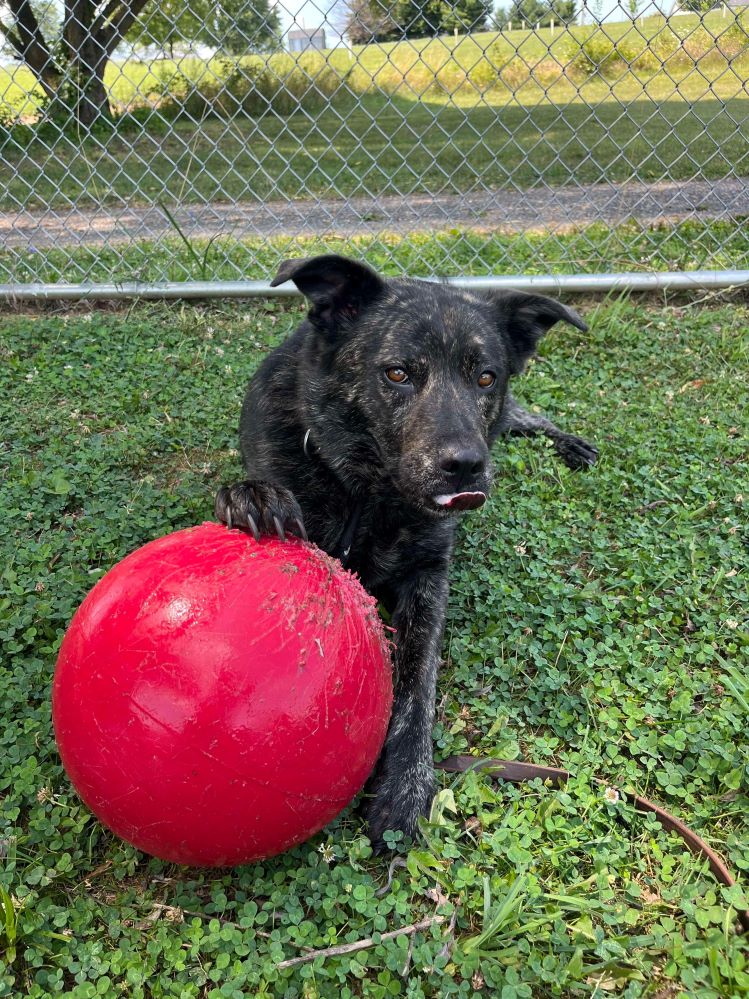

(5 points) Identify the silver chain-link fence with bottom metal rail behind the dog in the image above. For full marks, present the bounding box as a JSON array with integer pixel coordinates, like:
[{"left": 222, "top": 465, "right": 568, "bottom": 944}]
[{"left": 0, "top": 0, "right": 749, "bottom": 297}]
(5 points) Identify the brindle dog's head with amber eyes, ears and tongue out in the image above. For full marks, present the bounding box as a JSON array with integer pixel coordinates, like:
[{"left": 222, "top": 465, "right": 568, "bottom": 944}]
[{"left": 271, "top": 254, "right": 587, "bottom": 516}]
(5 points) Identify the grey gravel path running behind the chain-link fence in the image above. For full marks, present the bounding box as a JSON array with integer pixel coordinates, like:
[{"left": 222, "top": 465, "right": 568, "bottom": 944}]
[{"left": 0, "top": 178, "right": 749, "bottom": 250}]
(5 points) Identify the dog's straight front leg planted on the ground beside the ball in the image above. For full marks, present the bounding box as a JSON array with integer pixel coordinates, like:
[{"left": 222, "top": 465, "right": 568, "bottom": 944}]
[{"left": 362, "top": 571, "right": 448, "bottom": 852}]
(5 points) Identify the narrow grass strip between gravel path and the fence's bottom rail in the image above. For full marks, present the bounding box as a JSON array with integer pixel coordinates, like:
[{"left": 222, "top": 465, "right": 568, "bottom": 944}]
[{"left": 0, "top": 215, "right": 749, "bottom": 284}]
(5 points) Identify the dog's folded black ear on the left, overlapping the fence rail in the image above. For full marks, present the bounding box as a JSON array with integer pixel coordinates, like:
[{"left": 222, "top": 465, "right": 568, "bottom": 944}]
[{"left": 270, "top": 253, "right": 385, "bottom": 328}]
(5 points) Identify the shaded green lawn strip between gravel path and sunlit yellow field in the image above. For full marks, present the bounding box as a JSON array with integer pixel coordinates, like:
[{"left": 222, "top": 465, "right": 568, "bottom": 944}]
[{"left": 0, "top": 91, "right": 749, "bottom": 211}]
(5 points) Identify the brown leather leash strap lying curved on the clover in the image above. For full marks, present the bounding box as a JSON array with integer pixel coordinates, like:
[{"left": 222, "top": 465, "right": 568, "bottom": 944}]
[{"left": 435, "top": 756, "right": 749, "bottom": 933}]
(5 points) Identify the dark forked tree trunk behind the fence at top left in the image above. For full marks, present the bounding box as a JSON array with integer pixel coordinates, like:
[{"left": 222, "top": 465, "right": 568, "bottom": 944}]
[{"left": 0, "top": 0, "right": 152, "bottom": 127}]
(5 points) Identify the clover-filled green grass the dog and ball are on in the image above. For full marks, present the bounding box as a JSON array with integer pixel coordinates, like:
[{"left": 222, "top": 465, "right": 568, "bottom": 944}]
[{"left": 0, "top": 252, "right": 749, "bottom": 999}]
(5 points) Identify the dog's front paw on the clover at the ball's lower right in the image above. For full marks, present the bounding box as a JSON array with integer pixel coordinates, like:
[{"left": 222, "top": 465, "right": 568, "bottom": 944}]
[{"left": 360, "top": 764, "right": 435, "bottom": 853}]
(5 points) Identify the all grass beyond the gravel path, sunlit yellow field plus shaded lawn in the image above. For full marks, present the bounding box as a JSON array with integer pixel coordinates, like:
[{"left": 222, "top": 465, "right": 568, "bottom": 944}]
[{"left": 0, "top": 14, "right": 749, "bottom": 211}]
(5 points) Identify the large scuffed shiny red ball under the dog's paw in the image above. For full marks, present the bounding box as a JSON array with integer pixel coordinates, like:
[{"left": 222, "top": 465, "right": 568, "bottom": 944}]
[{"left": 52, "top": 524, "right": 392, "bottom": 867}]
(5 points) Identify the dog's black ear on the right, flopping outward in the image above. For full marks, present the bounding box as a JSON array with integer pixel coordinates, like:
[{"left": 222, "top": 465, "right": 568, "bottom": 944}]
[{"left": 490, "top": 291, "right": 588, "bottom": 375}]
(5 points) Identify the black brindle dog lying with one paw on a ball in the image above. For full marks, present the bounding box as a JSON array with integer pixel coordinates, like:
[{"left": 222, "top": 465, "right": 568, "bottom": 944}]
[{"left": 215, "top": 254, "right": 597, "bottom": 852}]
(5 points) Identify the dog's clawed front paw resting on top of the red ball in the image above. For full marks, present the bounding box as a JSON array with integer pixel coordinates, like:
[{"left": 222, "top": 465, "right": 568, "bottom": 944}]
[{"left": 214, "top": 482, "right": 307, "bottom": 541}]
